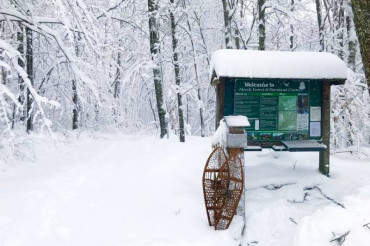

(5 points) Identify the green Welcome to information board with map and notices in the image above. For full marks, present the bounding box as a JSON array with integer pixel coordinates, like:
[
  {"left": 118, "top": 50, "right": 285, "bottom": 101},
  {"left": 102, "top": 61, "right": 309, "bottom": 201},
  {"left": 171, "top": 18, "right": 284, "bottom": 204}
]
[{"left": 225, "top": 79, "right": 321, "bottom": 142}]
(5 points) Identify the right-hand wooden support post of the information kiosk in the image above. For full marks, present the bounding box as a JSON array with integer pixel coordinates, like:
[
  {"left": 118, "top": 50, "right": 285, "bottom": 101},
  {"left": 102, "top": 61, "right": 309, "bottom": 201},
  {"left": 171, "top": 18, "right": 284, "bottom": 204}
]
[{"left": 319, "top": 81, "right": 331, "bottom": 176}]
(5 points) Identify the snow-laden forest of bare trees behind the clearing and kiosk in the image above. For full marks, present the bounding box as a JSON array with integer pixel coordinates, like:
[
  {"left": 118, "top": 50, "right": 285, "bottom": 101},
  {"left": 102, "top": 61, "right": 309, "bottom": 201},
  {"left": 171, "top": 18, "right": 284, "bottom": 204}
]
[{"left": 0, "top": 0, "right": 370, "bottom": 156}]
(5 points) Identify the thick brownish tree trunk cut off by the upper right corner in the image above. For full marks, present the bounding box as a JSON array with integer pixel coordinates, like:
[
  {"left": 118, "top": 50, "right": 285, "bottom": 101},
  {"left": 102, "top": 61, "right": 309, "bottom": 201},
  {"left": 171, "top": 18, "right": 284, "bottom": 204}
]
[{"left": 352, "top": 0, "right": 370, "bottom": 94}]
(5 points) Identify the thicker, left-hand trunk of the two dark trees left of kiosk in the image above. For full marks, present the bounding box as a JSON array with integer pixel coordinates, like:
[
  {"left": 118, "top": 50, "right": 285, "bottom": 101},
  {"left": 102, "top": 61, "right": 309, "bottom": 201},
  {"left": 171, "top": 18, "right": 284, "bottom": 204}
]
[{"left": 148, "top": 0, "right": 167, "bottom": 138}]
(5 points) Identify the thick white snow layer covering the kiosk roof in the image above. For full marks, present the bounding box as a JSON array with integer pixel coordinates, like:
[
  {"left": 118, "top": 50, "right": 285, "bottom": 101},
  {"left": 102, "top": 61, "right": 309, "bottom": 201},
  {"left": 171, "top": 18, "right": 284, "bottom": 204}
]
[{"left": 211, "top": 49, "right": 347, "bottom": 80}]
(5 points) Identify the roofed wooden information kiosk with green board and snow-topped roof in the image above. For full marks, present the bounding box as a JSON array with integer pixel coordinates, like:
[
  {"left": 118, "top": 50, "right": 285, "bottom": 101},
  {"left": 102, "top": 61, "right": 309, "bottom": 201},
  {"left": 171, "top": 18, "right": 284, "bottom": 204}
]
[{"left": 211, "top": 50, "right": 347, "bottom": 175}]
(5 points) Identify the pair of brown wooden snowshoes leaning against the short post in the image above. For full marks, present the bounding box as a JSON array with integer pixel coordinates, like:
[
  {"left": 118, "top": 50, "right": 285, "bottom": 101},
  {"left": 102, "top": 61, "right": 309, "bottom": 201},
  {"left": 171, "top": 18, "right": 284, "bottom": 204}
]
[{"left": 203, "top": 147, "right": 244, "bottom": 230}]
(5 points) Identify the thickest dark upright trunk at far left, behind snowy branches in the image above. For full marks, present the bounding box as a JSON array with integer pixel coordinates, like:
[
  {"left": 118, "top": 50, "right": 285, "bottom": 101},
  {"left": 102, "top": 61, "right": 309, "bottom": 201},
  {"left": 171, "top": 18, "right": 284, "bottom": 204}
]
[{"left": 26, "top": 27, "right": 34, "bottom": 133}]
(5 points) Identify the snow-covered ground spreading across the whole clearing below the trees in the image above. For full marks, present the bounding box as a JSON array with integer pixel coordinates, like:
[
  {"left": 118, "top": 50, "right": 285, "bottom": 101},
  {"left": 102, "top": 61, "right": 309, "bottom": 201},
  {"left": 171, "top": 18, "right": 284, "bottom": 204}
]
[{"left": 0, "top": 134, "right": 370, "bottom": 246}]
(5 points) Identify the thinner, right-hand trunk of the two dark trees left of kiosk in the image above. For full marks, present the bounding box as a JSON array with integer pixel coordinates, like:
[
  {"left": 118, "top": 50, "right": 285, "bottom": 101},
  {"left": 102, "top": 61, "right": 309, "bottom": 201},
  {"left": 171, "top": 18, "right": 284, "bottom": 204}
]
[{"left": 170, "top": 0, "right": 185, "bottom": 142}]
